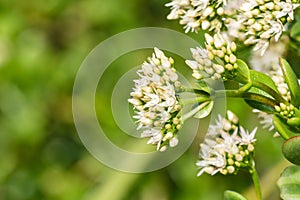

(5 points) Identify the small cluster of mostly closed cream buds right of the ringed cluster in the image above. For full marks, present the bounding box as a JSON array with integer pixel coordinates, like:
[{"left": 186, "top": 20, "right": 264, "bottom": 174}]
[{"left": 186, "top": 33, "right": 238, "bottom": 80}]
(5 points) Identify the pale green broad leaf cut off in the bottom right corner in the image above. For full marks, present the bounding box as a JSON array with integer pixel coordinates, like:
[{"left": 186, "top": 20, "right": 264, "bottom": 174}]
[{"left": 277, "top": 166, "right": 300, "bottom": 200}]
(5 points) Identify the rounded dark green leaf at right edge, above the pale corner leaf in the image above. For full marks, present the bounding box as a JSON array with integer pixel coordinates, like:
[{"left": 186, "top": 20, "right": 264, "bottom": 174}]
[{"left": 282, "top": 135, "right": 300, "bottom": 165}]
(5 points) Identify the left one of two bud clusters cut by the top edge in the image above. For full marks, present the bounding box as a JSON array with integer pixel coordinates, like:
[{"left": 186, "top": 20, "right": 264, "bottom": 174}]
[{"left": 166, "top": 0, "right": 230, "bottom": 32}]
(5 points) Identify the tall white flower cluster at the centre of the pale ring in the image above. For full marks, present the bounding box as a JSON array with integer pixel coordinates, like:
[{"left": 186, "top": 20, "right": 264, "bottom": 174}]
[{"left": 128, "top": 48, "right": 182, "bottom": 151}]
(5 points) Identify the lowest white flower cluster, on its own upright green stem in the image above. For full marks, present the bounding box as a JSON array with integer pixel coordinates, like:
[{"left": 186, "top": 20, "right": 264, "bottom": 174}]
[{"left": 196, "top": 111, "right": 257, "bottom": 176}]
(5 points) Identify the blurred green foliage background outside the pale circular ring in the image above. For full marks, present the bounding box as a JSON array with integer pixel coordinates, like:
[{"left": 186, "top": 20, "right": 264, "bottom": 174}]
[{"left": 0, "top": 0, "right": 296, "bottom": 200}]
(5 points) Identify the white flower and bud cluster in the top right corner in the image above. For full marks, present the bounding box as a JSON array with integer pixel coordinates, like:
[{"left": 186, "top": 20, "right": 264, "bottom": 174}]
[{"left": 236, "top": 0, "right": 299, "bottom": 55}]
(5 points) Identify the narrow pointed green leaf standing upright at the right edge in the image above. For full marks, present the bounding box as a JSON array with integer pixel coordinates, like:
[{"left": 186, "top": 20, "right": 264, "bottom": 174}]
[{"left": 279, "top": 58, "right": 300, "bottom": 108}]
